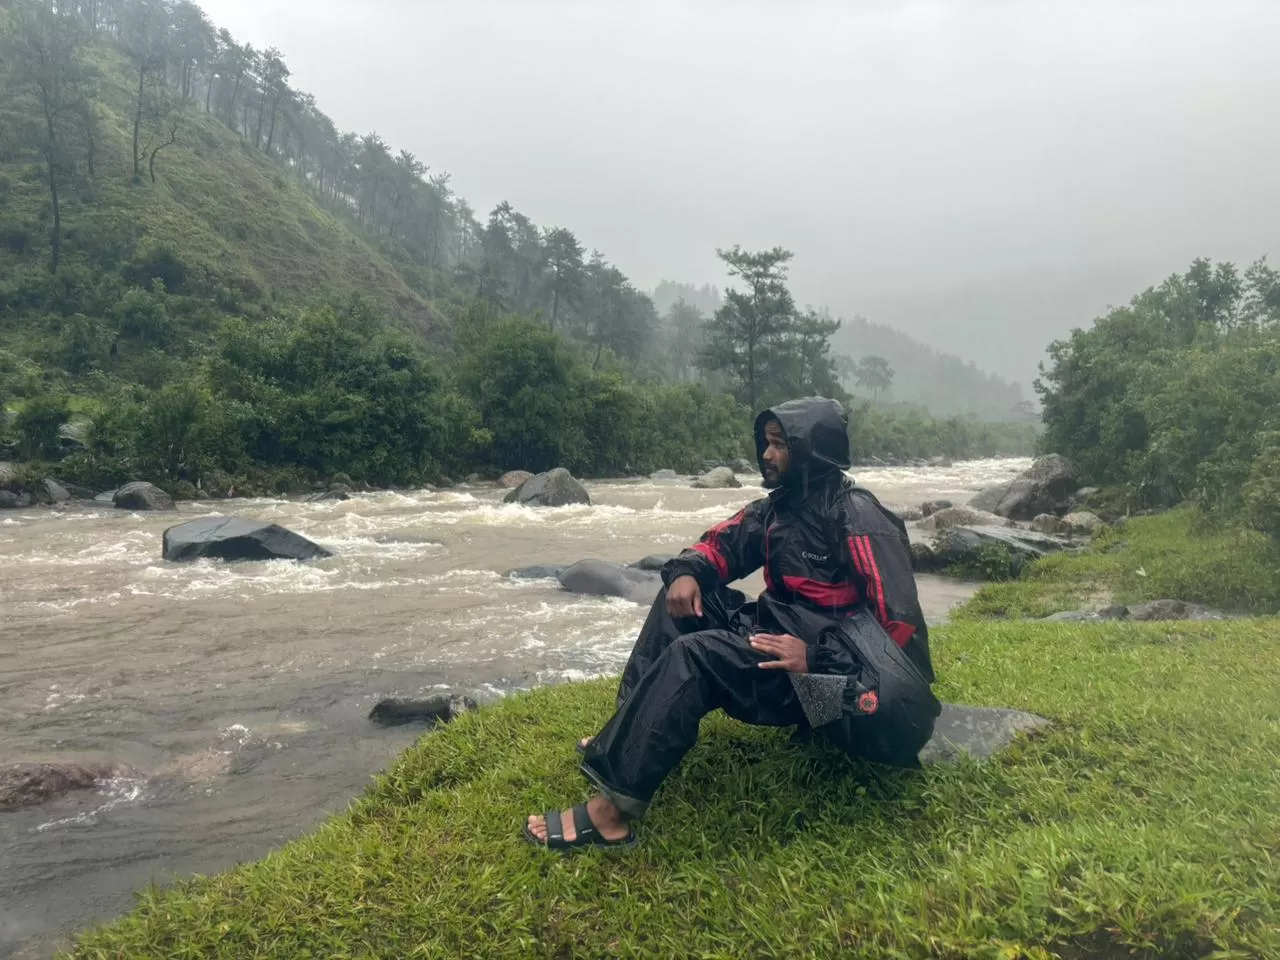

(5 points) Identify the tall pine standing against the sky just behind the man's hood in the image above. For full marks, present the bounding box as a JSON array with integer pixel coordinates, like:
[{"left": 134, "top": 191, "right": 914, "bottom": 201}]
[{"left": 704, "top": 244, "right": 795, "bottom": 410}]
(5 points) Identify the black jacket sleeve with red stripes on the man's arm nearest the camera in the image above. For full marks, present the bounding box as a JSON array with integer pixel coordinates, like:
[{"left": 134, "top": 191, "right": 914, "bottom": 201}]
[{"left": 809, "top": 494, "right": 928, "bottom": 673}]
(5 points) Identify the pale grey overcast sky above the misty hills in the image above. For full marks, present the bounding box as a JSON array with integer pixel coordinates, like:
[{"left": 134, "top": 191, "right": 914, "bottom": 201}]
[{"left": 192, "top": 0, "right": 1280, "bottom": 383}]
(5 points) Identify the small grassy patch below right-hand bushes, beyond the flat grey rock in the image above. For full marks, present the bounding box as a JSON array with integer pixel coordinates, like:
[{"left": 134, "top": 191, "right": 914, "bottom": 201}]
[{"left": 955, "top": 508, "right": 1280, "bottom": 620}]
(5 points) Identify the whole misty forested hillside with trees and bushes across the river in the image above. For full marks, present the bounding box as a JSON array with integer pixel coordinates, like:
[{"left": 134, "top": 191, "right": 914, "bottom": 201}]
[{"left": 0, "top": 0, "right": 1027, "bottom": 490}]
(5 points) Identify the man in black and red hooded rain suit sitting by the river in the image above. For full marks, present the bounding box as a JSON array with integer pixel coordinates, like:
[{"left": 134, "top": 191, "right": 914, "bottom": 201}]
[{"left": 525, "top": 397, "right": 941, "bottom": 850}]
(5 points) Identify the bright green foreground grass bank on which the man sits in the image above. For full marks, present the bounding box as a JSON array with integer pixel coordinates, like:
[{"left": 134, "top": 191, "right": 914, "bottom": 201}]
[{"left": 67, "top": 621, "right": 1280, "bottom": 957}]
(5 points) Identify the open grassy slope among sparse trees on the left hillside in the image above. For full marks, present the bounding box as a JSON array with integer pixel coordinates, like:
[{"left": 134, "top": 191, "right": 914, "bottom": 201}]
[{"left": 0, "top": 18, "right": 440, "bottom": 353}]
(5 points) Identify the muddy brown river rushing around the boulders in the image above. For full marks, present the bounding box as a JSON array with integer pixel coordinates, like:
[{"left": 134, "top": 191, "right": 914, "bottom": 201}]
[{"left": 0, "top": 461, "right": 1027, "bottom": 957}]
